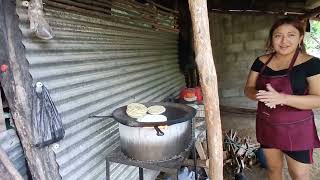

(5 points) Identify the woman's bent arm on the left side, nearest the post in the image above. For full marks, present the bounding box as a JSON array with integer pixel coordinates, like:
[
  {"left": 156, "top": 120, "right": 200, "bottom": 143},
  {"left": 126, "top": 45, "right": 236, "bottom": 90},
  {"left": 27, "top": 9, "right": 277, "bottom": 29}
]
[{"left": 244, "top": 71, "right": 259, "bottom": 101}]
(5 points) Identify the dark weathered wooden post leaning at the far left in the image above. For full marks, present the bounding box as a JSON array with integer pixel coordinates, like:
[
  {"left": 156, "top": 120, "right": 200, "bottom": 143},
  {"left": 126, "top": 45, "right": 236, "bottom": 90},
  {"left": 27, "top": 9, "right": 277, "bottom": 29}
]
[{"left": 0, "top": 0, "right": 61, "bottom": 180}]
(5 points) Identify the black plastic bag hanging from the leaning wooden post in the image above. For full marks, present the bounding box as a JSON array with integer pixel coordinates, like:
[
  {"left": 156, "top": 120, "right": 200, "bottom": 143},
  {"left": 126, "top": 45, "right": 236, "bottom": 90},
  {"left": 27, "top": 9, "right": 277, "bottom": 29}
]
[{"left": 31, "top": 82, "right": 65, "bottom": 147}]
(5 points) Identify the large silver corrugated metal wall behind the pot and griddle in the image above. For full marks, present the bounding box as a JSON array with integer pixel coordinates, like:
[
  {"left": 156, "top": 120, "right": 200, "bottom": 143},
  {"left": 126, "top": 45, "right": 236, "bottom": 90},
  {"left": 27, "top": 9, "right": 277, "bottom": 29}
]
[{"left": 17, "top": 0, "right": 184, "bottom": 180}]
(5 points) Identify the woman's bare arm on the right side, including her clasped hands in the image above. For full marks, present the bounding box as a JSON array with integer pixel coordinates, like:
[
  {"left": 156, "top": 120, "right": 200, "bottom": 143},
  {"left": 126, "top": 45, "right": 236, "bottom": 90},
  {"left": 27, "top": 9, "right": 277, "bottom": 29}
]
[{"left": 257, "top": 74, "right": 320, "bottom": 109}]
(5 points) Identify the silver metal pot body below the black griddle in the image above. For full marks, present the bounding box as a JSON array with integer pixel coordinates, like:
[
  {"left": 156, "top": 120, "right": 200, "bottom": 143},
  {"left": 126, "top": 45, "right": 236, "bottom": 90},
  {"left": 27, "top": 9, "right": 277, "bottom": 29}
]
[{"left": 119, "top": 121, "right": 192, "bottom": 160}]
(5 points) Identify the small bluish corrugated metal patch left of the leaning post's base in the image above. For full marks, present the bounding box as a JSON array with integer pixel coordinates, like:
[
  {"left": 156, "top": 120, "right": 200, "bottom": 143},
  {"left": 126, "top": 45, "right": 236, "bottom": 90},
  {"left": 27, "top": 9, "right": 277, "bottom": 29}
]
[{"left": 0, "top": 129, "right": 28, "bottom": 179}]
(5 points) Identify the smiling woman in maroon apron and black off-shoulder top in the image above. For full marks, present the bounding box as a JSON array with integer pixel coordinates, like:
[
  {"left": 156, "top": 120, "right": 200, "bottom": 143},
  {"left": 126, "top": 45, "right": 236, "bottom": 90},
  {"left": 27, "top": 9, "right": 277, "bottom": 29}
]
[{"left": 244, "top": 18, "right": 320, "bottom": 180}]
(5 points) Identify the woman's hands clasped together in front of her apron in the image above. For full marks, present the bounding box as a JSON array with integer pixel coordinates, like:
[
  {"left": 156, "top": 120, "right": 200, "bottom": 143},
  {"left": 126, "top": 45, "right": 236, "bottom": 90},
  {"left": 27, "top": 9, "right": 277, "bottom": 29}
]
[{"left": 256, "top": 84, "right": 286, "bottom": 108}]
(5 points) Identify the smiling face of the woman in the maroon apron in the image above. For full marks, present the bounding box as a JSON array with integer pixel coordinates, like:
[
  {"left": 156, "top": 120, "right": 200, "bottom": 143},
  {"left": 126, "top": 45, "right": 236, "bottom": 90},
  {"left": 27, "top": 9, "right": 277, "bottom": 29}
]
[{"left": 272, "top": 24, "right": 303, "bottom": 55}]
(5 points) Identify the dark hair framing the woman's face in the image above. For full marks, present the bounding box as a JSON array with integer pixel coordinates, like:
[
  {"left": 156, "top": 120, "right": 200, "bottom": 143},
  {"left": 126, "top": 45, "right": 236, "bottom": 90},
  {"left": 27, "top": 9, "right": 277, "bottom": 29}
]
[{"left": 266, "top": 17, "right": 305, "bottom": 51}]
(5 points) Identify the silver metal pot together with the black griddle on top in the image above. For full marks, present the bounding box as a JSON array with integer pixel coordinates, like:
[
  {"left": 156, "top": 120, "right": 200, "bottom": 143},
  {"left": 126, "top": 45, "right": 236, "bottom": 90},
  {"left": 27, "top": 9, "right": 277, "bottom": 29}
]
[{"left": 113, "top": 103, "right": 196, "bottom": 161}]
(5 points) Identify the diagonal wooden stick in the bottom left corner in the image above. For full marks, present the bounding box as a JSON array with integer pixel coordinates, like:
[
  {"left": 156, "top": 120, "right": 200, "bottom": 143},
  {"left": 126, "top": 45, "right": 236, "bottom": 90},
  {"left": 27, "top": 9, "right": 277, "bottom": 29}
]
[{"left": 0, "top": 146, "right": 23, "bottom": 180}]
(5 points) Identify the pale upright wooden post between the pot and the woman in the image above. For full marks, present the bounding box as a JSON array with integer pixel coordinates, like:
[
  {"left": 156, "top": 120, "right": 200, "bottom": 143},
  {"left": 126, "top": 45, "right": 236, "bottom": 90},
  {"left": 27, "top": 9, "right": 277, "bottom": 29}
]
[{"left": 189, "top": 0, "right": 223, "bottom": 180}]
